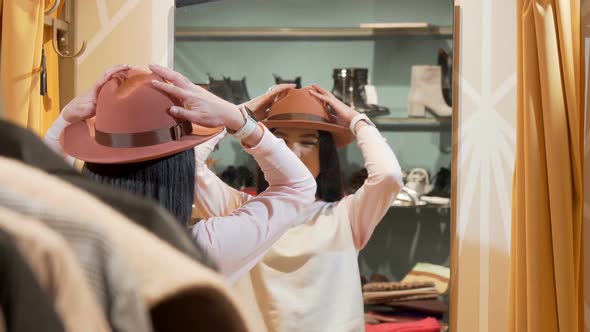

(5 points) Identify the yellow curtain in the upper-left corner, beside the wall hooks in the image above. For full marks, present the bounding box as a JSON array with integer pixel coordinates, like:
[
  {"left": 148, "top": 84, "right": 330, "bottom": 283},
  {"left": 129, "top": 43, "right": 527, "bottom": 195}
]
[{"left": 0, "top": 0, "right": 59, "bottom": 135}]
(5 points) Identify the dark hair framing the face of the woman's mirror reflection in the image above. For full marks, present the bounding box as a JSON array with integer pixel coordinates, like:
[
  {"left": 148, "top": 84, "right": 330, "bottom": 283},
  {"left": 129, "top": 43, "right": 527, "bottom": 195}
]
[{"left": 258, "top": 130, "right": 344, "bottom": 202}]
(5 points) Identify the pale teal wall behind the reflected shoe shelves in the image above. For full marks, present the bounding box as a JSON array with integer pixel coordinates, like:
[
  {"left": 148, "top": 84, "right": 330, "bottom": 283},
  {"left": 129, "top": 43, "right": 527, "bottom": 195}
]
[{"left": 174, "top": 0, "right": 453, "bottom": 177}]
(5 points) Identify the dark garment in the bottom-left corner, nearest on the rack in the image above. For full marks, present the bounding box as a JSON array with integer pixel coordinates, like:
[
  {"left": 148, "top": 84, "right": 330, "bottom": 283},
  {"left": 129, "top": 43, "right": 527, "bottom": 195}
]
[{"left": 0, "top": 229, "right": 65, "bottom": 332}]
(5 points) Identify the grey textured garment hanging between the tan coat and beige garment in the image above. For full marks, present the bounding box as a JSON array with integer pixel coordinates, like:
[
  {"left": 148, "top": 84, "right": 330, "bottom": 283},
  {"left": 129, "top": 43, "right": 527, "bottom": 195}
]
[{"left": 0, "top": 187, "right": 152, "bottom": 332}]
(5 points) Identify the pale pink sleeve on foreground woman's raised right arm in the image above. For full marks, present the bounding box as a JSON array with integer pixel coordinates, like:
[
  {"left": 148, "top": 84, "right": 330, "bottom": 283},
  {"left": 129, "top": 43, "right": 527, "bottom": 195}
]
[{"left": 192, "top": 128, "right": 316, "bottom": 282}]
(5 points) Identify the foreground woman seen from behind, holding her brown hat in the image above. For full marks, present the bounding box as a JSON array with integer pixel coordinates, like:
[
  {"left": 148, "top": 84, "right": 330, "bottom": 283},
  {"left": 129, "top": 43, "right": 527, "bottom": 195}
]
[{"left": 46, "top": 66, "right": 315, "bottom": 280}]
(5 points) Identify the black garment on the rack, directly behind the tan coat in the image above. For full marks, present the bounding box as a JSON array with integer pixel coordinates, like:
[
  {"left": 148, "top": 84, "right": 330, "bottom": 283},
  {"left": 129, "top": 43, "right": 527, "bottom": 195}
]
[{"left": 0, "top": 120, "right": 213, "bottom": 266}]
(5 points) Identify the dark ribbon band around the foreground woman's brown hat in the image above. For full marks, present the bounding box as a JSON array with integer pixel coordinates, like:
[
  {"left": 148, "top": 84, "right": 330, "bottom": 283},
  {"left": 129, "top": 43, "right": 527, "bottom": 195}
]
[{"left": 94, "top": 121, "right": 193, "bottom": 148}]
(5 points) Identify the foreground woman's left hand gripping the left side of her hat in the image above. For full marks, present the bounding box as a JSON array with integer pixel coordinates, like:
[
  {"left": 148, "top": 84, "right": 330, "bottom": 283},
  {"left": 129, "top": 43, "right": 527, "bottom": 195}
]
[{"left": 62, "top": 65, "right": 131, "bottom": 123}]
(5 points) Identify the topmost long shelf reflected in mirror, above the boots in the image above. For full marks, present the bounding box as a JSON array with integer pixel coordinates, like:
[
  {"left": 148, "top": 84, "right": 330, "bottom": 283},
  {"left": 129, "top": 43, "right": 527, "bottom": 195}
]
[{"left": 174, "top": 22, "right": 453, "bottom": 40}]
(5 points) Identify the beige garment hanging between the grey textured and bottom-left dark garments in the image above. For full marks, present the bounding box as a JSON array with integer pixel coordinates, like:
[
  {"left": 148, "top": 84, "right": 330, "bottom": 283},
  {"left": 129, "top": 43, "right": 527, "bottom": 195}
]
[{"left": 0, "top": 208, "right": 111, "bottom": 332}]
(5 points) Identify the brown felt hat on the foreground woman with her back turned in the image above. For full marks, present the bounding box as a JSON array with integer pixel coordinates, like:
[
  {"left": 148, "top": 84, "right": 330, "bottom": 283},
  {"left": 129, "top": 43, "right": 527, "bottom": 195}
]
[{"left": 60, "top": 69, "right": 221, "bottom": 164}]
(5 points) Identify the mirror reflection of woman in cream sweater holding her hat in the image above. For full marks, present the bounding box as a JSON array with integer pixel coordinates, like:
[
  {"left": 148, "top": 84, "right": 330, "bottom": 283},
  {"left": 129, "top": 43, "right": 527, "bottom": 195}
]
[{"left": 195, "top": 86, "right": 402, "bottom": 332}]
